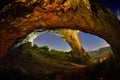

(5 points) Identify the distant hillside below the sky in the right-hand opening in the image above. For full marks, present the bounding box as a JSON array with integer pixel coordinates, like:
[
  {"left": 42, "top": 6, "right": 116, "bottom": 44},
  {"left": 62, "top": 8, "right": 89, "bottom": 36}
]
[{"left": 88, "top": 46, "right": 112, "bottom": 59}]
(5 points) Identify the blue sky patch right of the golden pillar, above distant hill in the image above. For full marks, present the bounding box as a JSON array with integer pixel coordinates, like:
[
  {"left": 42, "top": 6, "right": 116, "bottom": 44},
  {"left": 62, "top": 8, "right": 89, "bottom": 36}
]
[{"left": 78, "top": 32, "right": 109, "bottom": 51}]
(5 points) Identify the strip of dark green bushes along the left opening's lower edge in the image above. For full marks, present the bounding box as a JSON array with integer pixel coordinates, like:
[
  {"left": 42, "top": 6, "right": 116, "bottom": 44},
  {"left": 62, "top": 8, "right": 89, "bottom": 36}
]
[{"left": 10, "top": 42, "right": 89, "bottom": 64}]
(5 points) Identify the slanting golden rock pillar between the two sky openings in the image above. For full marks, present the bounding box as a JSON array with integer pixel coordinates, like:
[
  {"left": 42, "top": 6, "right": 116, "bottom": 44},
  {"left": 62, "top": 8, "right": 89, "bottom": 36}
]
[{"left": 55, "top": 29, "right": 90, "bottom": 58}]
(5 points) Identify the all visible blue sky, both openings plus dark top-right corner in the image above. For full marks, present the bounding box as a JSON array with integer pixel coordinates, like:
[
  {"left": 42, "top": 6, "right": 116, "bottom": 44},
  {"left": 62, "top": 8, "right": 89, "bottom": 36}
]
[{"left": 34, "top": 0, "right": 120, "bottom": 52}]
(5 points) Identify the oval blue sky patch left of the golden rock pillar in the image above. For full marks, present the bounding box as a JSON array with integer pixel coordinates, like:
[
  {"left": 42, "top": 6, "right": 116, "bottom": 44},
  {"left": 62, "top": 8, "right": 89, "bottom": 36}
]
[{"left": 34, "top": 33, "right": 71, "bottom": 50}]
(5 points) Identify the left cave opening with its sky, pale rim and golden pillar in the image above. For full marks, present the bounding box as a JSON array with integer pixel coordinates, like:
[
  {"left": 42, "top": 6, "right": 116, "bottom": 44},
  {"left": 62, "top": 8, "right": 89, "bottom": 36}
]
[{"left": 11, "top": 29, "right": 90, "bottom": 62}]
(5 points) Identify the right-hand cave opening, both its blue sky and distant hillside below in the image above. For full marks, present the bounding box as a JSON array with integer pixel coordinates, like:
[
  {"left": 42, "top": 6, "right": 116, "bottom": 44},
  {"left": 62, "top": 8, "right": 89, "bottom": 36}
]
[{"left": 78, "top": 32, "right": 113, "bottom": 61}]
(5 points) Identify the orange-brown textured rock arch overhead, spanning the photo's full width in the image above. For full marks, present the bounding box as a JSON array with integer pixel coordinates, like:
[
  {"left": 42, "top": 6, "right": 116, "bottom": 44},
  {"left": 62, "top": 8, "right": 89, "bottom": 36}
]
[{"left": 0, "top": 0, "right": 120, "bottom": 57}]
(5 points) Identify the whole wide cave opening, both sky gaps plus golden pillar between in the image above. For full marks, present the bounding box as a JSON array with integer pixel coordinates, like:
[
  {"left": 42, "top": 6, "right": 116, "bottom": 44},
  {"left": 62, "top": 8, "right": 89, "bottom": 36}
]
[{"left": 12, "top": 29, "right": 112, "bottom": 59}]
